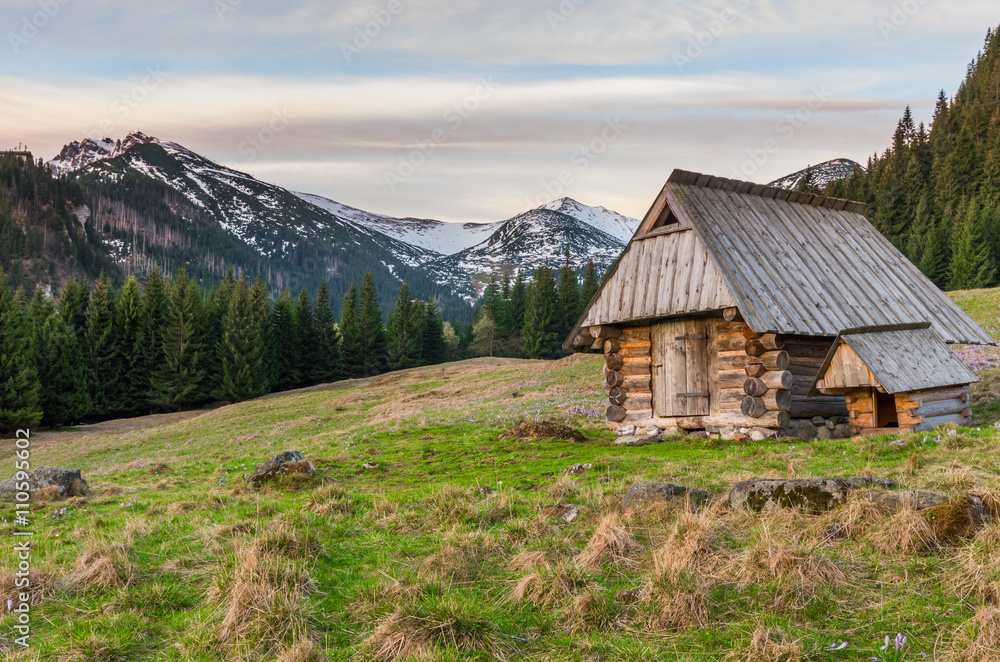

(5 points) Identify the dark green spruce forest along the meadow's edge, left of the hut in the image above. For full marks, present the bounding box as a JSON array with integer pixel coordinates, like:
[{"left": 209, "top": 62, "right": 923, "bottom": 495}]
[{"left": 0, "top": 256, "right": 597, "bottom": 431}]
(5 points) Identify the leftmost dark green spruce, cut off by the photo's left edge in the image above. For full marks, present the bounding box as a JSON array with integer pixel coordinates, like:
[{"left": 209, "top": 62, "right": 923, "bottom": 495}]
[{"left": 0, "top": 269, "right": 42, "bottom": 434}]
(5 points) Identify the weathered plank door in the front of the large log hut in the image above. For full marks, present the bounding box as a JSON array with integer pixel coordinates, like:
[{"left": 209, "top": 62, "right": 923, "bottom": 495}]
[{"left": 652, "top": 319, "right": 712, "bottom": 416}]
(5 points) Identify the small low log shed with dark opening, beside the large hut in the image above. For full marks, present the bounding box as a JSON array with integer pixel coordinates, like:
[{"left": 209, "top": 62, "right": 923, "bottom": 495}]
[{"left": 809, "top": 322, "right": 979, "bottom": 434}]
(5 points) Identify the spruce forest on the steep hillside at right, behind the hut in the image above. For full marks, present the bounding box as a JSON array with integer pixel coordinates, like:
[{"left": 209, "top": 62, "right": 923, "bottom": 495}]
[{"left": 828, "top": 30, "right": 1000, "bottom": 290}]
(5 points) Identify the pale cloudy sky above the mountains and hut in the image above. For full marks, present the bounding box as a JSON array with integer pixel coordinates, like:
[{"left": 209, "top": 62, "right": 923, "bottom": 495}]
[{"left": 0, "top": 0, "right": 1000, "bottom": 222}]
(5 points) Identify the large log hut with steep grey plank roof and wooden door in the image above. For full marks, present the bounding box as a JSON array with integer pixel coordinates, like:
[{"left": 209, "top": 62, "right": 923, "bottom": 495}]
[{"left": 563, "top": 170, "right": 995, "bottom": 430}]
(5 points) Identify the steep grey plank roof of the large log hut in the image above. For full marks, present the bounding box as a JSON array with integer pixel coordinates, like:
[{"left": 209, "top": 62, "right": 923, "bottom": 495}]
[{"left": 565, "top": 170, "right": 996, "bottom": 349}]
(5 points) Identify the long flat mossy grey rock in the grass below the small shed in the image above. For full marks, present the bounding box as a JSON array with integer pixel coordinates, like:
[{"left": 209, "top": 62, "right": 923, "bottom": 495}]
[{"left": 729, "top": 477, "right": 896, "bottom": 513}]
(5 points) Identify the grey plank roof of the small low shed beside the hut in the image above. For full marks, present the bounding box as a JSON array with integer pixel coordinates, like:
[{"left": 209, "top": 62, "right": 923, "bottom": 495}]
[{"left": 809, "top": 322, "right": 979, "bottom": 397}]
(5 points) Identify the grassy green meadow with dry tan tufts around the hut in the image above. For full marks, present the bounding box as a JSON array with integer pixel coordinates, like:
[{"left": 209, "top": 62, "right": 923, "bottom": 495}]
[{"left": 0, "top": 290, "right": 1000, "bottom": 662}]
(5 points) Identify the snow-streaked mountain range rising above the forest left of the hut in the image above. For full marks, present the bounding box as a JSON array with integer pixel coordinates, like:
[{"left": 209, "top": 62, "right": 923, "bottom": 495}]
[{"left": 49, "top": 132, "right": 639, "bottom": 312}]
